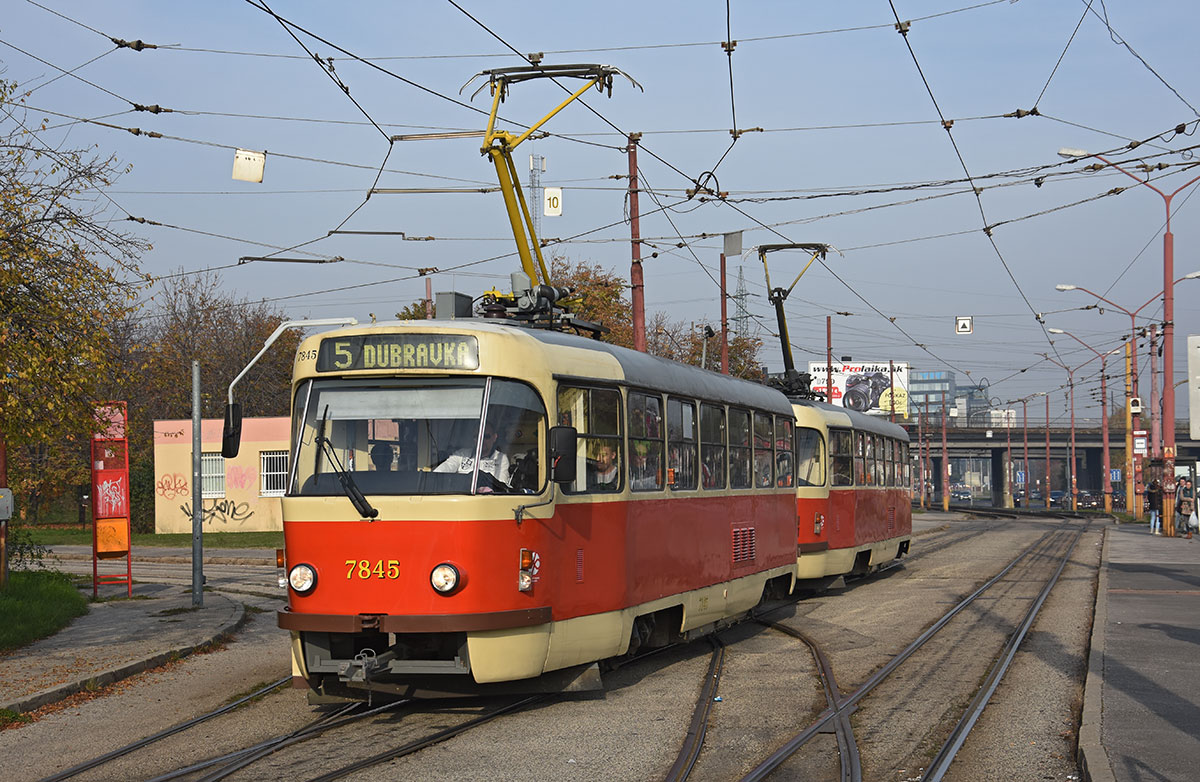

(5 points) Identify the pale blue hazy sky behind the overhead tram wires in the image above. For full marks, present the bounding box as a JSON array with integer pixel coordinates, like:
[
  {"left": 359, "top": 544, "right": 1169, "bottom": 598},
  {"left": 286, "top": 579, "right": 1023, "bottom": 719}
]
[{"left": 9, "top": 0, "right": 1200, "bottom": 424}]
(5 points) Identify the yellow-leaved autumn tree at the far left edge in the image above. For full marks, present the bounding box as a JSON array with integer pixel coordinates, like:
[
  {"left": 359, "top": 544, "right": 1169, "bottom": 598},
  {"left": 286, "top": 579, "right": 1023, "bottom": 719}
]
[{"left": 0, "top": 80, "right": 149, "bottom": 539}]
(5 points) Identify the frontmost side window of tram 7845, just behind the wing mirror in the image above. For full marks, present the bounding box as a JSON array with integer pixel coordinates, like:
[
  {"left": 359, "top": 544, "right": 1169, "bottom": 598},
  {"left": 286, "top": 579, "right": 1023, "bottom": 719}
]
[{"left": 558, "top": 386, "right": 623, "bottom": 493}]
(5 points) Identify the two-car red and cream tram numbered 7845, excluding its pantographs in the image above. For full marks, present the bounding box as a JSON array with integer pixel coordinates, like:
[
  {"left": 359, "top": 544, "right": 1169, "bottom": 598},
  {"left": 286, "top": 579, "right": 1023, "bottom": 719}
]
[{"left": 225, "top": 319, "right": 911, "bottom": 699}]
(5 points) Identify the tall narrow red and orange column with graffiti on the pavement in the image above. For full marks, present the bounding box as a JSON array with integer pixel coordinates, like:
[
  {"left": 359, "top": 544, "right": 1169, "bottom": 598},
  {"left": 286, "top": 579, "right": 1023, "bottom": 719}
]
[{"left": 91, "top": 402, "right": 133, "bottom": 597}]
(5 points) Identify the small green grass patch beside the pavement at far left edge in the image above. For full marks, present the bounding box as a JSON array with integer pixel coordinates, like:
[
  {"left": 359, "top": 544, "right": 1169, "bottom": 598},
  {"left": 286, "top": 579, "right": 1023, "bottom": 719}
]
[{"left": 0, "top": 570, "right": 88, "bottom": 651}]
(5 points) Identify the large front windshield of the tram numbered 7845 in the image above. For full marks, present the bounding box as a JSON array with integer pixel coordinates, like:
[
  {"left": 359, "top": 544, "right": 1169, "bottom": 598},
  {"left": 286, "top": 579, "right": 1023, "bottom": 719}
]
[{"left": 288, "top": 378, "right": 546, "bottom": 497}]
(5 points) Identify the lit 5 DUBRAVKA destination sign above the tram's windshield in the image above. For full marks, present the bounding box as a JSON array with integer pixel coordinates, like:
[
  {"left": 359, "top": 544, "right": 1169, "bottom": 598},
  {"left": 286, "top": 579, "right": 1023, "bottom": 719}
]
[{"left": 317, "top": 333, "right": 479, "bottom": 372}]
